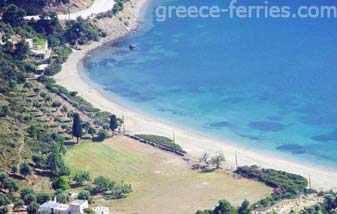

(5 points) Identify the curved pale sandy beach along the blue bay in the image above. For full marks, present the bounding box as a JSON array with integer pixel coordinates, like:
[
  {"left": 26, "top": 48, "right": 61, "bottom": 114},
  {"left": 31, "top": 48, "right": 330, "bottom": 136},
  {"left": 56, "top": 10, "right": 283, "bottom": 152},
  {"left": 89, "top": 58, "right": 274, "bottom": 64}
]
[{"left": 54, "top": 0, "right": 337, "bottom": 190}]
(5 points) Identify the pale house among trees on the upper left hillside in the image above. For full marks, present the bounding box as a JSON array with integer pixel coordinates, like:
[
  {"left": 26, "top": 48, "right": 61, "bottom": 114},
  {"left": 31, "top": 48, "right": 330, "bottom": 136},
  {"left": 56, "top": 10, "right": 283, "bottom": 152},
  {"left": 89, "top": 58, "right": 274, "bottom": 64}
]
[{"left": 26, "top": 39, "right": 51, "bottom": 61}]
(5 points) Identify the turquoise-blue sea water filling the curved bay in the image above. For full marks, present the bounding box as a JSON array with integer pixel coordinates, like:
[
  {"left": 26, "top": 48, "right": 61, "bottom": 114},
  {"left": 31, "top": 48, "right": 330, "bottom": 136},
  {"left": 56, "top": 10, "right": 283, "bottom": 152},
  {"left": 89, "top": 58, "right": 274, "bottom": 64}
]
[{"left": 84, "top": 0, "right": 337, "bottom": 168}]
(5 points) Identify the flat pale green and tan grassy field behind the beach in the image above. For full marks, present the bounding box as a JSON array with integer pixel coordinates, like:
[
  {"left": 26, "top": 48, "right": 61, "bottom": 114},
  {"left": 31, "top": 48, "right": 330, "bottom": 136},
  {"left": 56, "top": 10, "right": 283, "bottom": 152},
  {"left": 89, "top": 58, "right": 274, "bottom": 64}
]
[{"left": 66, "top": 137, "right": 271, "bottom": 213}]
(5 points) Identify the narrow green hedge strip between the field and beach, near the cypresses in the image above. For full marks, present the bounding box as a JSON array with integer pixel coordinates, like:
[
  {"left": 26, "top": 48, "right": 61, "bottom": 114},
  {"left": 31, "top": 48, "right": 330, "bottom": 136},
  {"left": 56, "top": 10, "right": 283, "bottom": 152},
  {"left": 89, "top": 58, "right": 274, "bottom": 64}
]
[{"left": 135, "top": 134, "right": 186, "bottom": 154}]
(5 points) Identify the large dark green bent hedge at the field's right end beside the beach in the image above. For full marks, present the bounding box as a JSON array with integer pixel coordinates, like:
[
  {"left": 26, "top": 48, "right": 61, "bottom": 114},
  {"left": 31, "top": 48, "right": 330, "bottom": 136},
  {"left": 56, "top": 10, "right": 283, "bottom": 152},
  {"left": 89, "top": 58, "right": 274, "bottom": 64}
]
[{"left": 236, "top": 165, "right": 308, "bottom": 209}]
